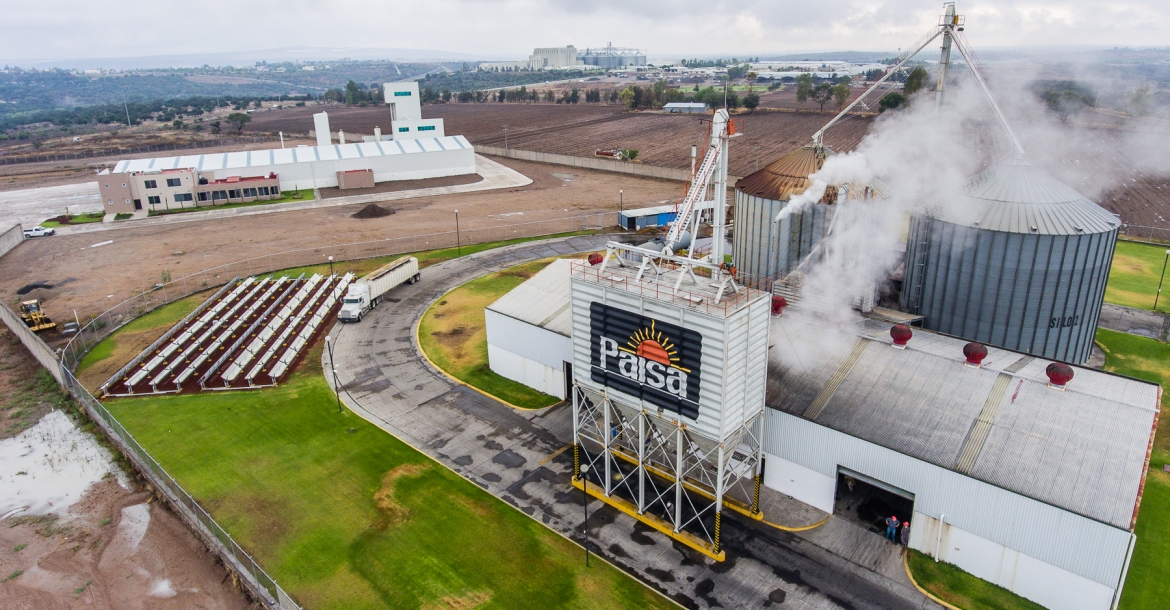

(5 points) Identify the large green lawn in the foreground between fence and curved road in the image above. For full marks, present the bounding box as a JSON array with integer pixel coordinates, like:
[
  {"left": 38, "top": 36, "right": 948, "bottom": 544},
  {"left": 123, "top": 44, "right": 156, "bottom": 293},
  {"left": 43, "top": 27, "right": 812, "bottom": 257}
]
[{"left": 108, "top": 345, "right": 672, "bottom": 609}]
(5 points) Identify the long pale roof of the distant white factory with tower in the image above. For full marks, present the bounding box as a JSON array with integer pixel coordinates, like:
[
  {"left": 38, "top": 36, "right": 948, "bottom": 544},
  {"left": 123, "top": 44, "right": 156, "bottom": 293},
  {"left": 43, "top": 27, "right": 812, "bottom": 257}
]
[{"left": 113, "top": 136, "right": 472, "bottom": 173}]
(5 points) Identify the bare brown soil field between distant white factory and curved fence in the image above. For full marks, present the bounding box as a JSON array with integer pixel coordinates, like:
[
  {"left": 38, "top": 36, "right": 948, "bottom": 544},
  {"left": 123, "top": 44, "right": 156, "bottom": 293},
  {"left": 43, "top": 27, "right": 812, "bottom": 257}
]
[{"left": 0, "top": 159, "right": 681, "bottom": 323}]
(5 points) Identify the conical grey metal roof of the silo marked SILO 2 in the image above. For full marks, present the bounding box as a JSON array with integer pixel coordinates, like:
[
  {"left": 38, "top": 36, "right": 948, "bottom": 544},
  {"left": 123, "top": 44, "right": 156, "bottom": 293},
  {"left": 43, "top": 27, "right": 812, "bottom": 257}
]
[{"left": 928, "top": 159, "right": 1121, "bottom": 235}]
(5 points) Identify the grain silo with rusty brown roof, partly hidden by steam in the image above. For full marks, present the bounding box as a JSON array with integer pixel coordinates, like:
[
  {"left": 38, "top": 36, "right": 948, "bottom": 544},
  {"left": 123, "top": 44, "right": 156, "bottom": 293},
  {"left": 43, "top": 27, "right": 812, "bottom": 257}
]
[{"left": 732, "top": 145, "right": 838, "bottom": 281}]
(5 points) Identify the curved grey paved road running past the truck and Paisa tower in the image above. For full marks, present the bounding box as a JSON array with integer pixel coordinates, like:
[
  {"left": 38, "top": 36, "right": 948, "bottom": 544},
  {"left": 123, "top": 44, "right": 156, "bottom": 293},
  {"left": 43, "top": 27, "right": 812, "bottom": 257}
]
[{"left": 325, "top": 237, "right": 937, "bottom": 609}]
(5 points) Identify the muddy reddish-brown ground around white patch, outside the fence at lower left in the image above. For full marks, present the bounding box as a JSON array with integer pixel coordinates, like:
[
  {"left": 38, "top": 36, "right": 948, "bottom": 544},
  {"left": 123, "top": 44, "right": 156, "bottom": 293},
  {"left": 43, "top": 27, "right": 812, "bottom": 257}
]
[{"left": 0, "top": 327, "right": 255, "bottom": 610}]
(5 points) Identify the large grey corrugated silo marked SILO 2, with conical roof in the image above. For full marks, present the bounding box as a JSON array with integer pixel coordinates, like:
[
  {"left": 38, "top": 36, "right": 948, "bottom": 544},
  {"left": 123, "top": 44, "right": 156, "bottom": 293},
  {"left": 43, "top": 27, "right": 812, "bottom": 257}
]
[{"left": 901, "top": 158, "right": 1120, "bottom": 364}]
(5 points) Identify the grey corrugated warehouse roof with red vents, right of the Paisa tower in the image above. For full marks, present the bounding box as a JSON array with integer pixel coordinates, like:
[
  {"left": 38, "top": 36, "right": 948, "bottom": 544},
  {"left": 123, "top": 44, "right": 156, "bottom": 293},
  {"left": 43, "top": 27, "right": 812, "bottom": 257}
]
[{"left": 768, "top": 320, "right": 1159, "bottom": 529}]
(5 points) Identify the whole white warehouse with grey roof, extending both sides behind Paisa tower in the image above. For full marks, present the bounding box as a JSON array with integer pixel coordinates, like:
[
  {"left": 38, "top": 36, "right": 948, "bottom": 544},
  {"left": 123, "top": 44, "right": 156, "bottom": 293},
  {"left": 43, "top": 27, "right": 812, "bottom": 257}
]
[{"left": 486, "top": 260, "right": 1161, "bottom": 610}]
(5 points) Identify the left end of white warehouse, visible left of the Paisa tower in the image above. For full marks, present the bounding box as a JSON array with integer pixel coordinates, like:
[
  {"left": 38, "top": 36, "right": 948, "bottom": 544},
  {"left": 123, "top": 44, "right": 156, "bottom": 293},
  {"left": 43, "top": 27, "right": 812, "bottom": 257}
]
[{"left": 483, "top": 259, "right": 572, "bottom": 399}]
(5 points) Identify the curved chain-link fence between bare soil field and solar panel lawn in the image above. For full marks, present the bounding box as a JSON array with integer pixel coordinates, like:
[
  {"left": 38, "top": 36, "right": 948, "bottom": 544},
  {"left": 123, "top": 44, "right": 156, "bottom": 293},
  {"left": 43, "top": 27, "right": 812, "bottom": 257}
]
[{"left": 61, "top": 212, "right": 617, "bottom": 371}]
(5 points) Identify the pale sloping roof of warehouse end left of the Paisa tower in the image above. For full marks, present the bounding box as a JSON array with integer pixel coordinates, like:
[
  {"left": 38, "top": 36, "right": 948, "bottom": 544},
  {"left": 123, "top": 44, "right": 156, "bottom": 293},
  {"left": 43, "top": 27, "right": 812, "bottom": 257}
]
[{"left": 488, "top": 259, "right": 573, "bottom": 337}]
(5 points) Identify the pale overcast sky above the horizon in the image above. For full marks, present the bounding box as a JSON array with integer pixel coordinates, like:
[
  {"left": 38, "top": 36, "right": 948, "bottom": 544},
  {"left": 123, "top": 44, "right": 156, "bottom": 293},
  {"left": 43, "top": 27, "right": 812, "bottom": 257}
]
[{"left": 0, "top": 0, "right": 1170, "bottom": 64}]
